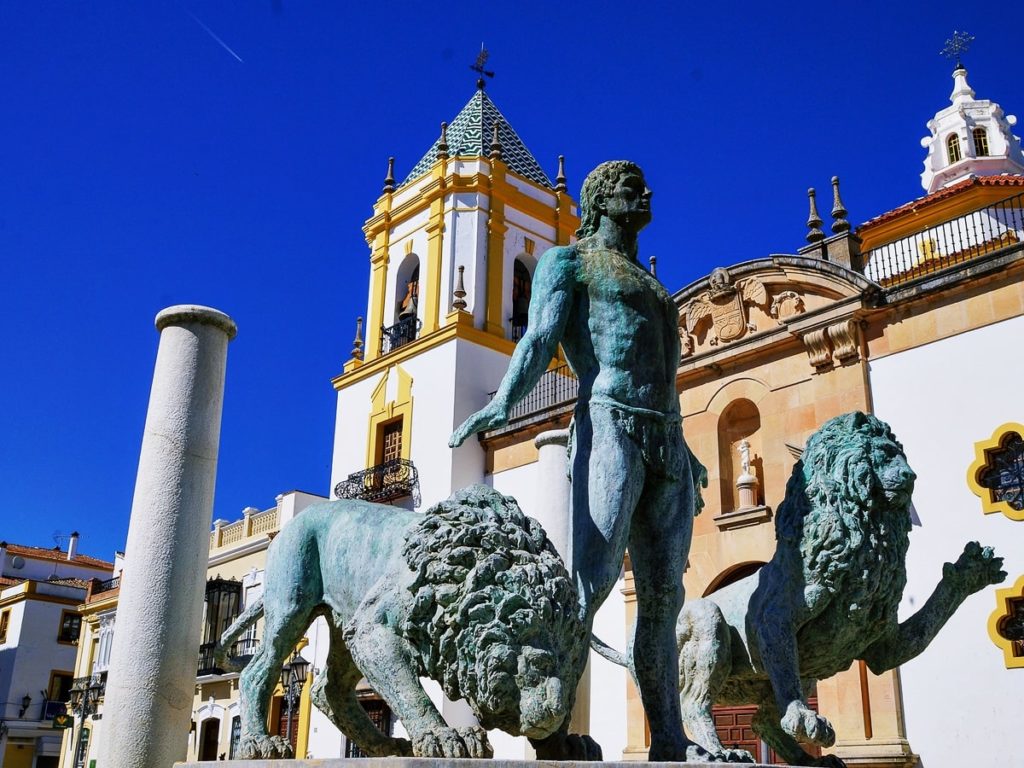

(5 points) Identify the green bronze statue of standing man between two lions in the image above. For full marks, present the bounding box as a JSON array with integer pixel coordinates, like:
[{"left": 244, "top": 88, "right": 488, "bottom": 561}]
[{"left": 451, "top": 161, "right": 709, "bottom": 761}]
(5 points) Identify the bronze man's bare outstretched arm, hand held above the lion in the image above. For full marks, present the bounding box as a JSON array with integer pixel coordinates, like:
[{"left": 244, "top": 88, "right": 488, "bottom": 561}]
[{"left": 449, "top": 247, "right": 577, "bottom": 447}]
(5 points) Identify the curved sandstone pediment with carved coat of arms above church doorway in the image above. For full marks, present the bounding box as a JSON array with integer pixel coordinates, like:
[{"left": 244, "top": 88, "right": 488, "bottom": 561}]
[{"left": 674, "top": 255, "right": 878, "bottom": 367}]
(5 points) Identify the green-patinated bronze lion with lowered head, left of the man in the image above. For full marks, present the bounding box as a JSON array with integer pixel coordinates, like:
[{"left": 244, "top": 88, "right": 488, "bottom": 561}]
[{"left": 220, "top": 485, "right": 587, "bottom": 758}]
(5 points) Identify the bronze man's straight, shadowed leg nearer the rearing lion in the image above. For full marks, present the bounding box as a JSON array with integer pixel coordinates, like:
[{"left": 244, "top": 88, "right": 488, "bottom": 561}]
[{"left": 627, "top": 477, "right": 709, "bottom": 761}]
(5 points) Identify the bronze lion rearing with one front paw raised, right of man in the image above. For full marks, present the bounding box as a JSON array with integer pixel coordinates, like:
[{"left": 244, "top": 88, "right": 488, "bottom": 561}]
[{"left": 677, "top": 413, "right": 1006, "bottom": 766}]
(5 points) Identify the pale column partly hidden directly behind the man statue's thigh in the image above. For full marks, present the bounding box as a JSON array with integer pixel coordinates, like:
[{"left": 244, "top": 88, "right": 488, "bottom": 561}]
[{"left": 532, "top": 429, "right": 590, "bottom": 734}]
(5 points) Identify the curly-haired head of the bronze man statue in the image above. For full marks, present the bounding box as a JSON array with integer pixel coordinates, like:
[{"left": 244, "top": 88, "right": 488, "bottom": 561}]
[{"left": 577, "top": 160, "right": 650, "bottom": 238}]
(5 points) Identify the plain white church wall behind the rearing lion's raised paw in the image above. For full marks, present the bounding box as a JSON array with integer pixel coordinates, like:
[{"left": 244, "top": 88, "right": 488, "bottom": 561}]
[{"left": 870, "top": 317, "right": 1024, "bottom": 768}]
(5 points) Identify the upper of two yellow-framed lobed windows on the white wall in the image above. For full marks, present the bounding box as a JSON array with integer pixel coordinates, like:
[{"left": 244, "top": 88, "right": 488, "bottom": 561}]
[{"left": 967, "top": 422, "right": 1024, "bottom": 520}]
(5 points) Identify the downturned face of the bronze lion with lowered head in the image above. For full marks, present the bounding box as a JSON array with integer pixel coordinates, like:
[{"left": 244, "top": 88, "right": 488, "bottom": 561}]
[{"left": 470, "top": 645, "right": 571, "bottom": 738}]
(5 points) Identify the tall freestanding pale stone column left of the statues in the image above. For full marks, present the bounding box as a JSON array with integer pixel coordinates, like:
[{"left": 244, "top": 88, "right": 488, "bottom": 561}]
[{"left": 98, "top": 305, "right": 237, "bottom": 768}]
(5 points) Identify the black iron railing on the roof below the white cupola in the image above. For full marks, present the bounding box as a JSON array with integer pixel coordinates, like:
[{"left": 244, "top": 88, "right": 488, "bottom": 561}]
[{"left": 864, "top": 193, "right": 1024, "bottom": 287}]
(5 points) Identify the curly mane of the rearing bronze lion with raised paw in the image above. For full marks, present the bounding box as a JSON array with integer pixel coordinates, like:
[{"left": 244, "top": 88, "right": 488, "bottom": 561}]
[{"left": 775, "top": 412, "right": 913, "bottom": 618}]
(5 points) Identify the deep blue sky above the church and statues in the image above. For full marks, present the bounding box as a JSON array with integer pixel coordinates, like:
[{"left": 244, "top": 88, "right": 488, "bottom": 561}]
[{"left": 0, "top": 0, "right": 1024, "bottom": 557}]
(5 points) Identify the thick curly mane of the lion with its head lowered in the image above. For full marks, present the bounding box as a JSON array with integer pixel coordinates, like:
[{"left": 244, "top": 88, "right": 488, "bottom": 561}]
[{"left": 401, "top": 485, "right": 587, "bottom": 733}]
